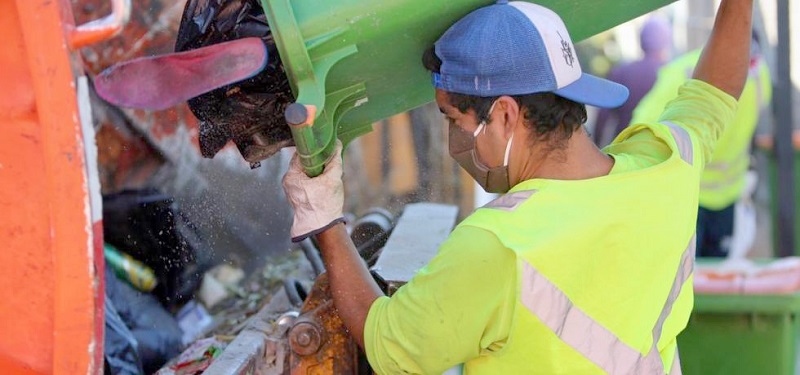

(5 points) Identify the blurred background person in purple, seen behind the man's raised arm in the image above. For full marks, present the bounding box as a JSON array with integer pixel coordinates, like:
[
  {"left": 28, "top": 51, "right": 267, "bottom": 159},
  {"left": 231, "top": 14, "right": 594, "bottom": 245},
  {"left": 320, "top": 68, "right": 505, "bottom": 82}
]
[{"left": 593, "top": 16, "right": 672, "bottom": 147}]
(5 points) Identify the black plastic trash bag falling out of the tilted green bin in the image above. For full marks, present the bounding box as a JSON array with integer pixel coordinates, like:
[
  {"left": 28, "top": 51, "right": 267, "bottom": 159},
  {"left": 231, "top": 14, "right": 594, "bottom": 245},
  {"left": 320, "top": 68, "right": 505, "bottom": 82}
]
[{"left": 175, "top": 0, "right": 294, "bottom": 166}]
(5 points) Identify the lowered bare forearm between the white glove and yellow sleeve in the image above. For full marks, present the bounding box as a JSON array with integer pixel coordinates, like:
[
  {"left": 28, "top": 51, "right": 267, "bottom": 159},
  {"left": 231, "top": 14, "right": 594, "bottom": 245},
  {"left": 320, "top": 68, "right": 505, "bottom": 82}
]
[{"left": 317, "top": 223, "right": 383, "bottom": 348}]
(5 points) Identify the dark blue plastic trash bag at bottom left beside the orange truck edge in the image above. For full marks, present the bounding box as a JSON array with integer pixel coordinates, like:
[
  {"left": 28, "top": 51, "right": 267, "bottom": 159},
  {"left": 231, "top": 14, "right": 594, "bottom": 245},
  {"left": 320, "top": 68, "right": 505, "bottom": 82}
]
[{"left": 105, "top": 268, "right": 183, "bottom": 374}]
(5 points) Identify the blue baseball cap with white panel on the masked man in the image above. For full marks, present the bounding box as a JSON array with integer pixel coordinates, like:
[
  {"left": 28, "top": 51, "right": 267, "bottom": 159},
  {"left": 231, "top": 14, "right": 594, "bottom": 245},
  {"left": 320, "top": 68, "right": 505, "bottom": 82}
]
[{"left": 433, "top": 0, "right": 628, "bottom": 108}]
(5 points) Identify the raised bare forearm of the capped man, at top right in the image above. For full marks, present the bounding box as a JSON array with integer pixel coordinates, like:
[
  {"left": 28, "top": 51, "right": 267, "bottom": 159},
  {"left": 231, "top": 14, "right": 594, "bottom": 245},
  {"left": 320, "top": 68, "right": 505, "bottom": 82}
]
[{"left": 694, "top": 0, "right": 753, "bottom": 99}]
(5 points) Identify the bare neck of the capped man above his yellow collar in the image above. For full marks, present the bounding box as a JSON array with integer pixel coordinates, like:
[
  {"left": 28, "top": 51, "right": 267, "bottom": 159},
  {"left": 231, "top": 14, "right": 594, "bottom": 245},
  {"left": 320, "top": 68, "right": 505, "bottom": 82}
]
[{"left": 512, "top": 127, "right": 614, "bottom": 182}]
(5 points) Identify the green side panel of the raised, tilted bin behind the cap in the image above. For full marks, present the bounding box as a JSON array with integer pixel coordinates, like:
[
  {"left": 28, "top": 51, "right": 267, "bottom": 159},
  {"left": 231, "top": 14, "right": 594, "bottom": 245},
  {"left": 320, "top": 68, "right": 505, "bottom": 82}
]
[{"left": 306, "top": 0, "right": 671, "bottom": 132}]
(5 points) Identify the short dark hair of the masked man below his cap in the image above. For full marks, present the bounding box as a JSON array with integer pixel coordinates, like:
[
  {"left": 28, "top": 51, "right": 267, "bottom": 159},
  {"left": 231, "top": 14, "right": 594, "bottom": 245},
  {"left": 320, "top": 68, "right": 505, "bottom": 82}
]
[{"left": 422, "top": 47, "right": 586, "bottom": 148}]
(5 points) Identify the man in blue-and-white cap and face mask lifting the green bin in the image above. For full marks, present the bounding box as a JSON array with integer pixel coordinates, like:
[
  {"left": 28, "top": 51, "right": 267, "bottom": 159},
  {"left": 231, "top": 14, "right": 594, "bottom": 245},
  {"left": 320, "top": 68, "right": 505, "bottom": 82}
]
[{"left": 284, "top": 0, "right": 753, "bottom": 374}]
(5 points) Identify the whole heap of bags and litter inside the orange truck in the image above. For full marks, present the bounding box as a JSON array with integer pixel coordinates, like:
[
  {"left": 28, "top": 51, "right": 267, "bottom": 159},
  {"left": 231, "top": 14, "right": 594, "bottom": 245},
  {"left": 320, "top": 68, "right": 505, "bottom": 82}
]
[{"left": 104, "top": 189, "right": 316, "bottom": 375}]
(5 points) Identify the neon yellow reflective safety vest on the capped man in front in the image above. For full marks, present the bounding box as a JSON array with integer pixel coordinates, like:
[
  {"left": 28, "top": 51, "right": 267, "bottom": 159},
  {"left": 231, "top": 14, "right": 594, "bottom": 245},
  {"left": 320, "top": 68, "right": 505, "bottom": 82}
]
[{"left": 459, "top": 124, "right": 702, "bottom": 374}]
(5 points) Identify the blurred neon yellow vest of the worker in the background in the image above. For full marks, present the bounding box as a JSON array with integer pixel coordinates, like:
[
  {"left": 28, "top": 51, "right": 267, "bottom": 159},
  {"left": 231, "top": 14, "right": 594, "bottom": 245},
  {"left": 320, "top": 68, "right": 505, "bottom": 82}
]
[{"left": 631, "top": 50, "right": 772, "bottom": 210}]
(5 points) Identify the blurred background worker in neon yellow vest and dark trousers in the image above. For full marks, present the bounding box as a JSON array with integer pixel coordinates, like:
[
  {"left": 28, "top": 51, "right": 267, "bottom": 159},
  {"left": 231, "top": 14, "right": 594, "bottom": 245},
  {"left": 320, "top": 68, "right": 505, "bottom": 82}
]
[{"left": 633, "top": 34, "right": 772, "bottom": 257}]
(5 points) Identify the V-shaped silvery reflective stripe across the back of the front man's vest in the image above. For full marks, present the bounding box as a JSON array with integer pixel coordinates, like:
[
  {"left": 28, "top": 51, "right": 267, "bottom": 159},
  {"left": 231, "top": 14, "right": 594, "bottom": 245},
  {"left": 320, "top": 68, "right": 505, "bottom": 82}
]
[{"left": 520, "top": 237, "right": 695, "bottom": 375}]
